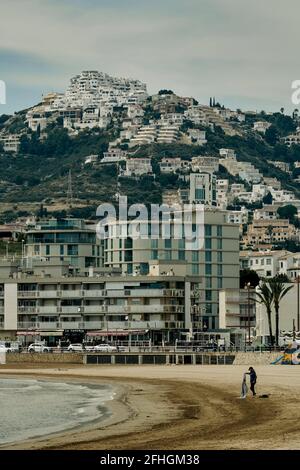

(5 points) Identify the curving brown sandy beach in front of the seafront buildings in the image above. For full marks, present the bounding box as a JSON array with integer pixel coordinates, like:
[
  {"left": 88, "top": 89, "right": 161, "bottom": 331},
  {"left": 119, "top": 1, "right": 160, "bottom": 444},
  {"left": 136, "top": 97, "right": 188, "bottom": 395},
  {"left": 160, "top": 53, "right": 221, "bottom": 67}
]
[{"left": 0, "top": 364, "right": 300, "bottom": 450}]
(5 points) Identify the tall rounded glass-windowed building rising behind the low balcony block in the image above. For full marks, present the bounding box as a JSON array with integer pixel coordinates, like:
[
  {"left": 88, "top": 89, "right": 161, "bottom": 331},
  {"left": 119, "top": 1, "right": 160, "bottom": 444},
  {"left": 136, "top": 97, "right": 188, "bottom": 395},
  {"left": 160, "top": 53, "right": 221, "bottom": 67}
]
[{"left": 104, "top": 210, "right": 239, "bottom": 328}]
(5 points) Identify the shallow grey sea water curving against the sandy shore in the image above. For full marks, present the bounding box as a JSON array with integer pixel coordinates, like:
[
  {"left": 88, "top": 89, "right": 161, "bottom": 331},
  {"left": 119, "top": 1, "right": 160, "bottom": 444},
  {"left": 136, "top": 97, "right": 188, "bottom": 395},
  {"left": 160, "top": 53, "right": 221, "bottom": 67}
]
[{"left": 0, "top": 378, "right": 114, "bottom": 444}]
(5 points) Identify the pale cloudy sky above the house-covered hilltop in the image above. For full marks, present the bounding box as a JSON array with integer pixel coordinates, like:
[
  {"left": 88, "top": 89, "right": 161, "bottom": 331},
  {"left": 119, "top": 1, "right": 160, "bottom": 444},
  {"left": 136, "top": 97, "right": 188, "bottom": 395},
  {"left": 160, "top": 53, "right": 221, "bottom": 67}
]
[{"left": 0, "top": 0, "right": 300, "bottom": 114}]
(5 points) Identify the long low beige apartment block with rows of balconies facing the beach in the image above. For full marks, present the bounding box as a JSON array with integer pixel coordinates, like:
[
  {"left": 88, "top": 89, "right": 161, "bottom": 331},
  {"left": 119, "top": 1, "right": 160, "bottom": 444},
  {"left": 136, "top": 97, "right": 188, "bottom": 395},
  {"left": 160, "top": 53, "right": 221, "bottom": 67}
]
[{"left": 0, "top": 273, "right": 202, "bottom": 345}]
